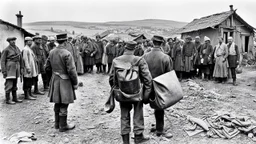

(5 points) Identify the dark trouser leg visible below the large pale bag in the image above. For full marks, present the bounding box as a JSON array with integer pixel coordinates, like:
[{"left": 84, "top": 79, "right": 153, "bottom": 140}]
[{"left": 154, "top": 110, "right": 164, "bottom": 133}]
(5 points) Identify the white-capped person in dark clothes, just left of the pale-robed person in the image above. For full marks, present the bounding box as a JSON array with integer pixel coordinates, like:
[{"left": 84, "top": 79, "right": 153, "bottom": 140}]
[{"left": 200, "top": 36, "right": 213, "bottom": 81}]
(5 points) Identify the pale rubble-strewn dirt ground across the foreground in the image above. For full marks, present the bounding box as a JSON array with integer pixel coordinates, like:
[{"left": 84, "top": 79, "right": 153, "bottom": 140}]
[{"left": 0, "top": 67, "right": 256, "bottom": 144}]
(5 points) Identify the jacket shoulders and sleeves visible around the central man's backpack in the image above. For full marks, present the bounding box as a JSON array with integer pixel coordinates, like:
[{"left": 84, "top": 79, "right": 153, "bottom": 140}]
[{"left": 109, "top": 52, "right": 152, "bottom": 103}]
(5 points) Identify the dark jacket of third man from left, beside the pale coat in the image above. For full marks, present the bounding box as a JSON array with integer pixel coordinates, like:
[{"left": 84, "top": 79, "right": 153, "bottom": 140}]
[{"left": 31, "top": 43, "right": 47, "bottom": 73}]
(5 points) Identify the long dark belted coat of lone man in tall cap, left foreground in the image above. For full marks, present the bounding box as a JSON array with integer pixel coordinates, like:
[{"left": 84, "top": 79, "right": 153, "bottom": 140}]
[{"left": 45, "top": 46, "right": 78, "bottom": 104}]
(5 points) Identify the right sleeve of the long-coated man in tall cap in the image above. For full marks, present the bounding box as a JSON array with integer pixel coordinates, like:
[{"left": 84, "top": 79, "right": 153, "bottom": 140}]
[{"left": 65, "top": 53, "right": 78, "bottom": 85}]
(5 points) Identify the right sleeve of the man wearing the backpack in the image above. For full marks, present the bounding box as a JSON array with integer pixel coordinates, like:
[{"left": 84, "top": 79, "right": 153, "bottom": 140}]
[{"left": 139, "top": 58, "right": 152, "bottom": 103}]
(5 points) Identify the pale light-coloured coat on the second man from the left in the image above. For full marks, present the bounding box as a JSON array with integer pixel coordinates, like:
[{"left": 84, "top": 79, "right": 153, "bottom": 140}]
[{"left": 22, "top": 45, "right": 38, "bottom": 78}]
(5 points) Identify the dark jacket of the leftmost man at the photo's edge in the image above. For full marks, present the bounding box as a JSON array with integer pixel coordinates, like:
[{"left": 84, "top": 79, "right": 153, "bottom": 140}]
[{"left": 1, "top": 45, "right": 21, "bottom": 79}]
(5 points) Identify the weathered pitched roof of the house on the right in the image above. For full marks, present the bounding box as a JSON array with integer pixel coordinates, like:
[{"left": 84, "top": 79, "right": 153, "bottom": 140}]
[{"left": 178, "top": 10, "right": 254, "bottom": 33}]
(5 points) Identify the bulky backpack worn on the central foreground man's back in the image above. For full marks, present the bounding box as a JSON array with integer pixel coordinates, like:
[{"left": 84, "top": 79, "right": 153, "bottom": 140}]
[{"left": 114, "top": 56, "right": 143, "bottom": 102}]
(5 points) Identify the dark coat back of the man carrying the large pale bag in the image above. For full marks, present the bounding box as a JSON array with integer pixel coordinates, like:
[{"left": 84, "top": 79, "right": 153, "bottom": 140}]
[{"left": 144, "top": 48, "right": 173, "bottom": 78}]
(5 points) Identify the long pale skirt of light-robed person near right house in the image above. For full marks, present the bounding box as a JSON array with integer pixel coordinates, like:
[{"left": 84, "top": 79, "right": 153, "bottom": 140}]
[{"left": 213, "top": 56, "right": 228, "bottom": 78}]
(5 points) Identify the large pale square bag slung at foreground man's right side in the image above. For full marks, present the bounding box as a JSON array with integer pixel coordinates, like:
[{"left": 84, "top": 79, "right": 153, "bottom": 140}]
[{"left": 150, "top": 70, "right": 183, "bottom": 109}]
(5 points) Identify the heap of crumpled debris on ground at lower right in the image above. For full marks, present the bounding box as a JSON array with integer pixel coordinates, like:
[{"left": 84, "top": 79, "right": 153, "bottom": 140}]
[{"left": 185, "top": 113, "right": 256, "bottom": 141}]
